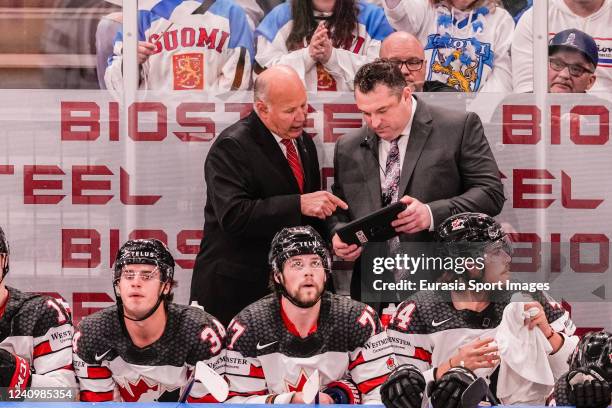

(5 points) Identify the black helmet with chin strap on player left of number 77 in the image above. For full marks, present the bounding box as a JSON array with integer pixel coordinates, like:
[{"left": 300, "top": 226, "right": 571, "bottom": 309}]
[{"left": 113, "top": 239, "right": 174, "bottom": 323}]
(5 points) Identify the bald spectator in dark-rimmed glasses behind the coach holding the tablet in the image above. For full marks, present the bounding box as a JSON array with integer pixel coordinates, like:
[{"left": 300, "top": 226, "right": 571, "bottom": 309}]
[{"left": 380, "top": 31, "right": 457, "bottom": 92}]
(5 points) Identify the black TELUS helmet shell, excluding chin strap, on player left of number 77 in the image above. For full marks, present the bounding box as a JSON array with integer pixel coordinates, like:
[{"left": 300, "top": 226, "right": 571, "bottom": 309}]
[{"left": 113, "top": 239, "right": 174, "bottom": 283}]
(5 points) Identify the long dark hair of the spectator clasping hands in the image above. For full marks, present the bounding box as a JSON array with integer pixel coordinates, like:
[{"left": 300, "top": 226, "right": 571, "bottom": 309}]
[{"left": 286, "top": 0, "right": 359, "bottom": 51}]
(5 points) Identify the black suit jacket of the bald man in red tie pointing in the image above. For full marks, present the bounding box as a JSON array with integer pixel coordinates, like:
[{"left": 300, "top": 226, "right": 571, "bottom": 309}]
[{"left": 191, "top": 112, "right": 325, "bottom": 324}]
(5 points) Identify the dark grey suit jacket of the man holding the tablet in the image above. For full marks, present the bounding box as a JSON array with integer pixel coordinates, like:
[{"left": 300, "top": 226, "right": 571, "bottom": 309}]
[{"left": 328, "top": 96, "right": 505, "bottom": 301}]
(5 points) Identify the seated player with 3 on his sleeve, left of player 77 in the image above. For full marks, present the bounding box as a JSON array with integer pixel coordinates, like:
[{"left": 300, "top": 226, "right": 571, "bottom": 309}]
[{"left": 73, "top": 239, "right": 225, "bottom": 402}]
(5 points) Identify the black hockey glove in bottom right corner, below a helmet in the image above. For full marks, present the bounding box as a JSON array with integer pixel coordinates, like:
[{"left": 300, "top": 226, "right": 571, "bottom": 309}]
[{"left": 555, "top": 368, "right": 610, "bottom": 408}]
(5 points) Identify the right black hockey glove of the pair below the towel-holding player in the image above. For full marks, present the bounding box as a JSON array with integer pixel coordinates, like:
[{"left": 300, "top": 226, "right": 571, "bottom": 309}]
[{"left": 427, "top": 367, "right": 478, "bottom": 408}]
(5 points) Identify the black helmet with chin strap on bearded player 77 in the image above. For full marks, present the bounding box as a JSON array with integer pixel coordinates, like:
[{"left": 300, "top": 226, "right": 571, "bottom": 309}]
[{"left": 268, "top": 225, "right": 332, "bottom": 307}]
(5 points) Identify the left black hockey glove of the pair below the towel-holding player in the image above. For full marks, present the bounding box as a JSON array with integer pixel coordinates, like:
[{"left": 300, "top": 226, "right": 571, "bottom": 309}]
[{"left": 380, "top": 364, "right": 425, "bottom": 408}]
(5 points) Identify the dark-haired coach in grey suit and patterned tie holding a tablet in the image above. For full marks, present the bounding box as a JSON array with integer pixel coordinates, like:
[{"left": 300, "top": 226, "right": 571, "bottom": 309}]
[{"left": 330, "top": 60, "right": 505, "bottom": 299}]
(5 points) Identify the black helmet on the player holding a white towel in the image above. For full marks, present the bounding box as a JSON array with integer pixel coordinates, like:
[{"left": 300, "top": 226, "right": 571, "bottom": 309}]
[{"left": 436, "top": 213, "right": 512, "bottom": 256}]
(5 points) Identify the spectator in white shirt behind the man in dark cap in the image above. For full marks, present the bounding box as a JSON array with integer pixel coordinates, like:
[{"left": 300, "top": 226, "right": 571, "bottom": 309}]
[{"left": 512, "top": 0, "right": 612, "bottom": 92}]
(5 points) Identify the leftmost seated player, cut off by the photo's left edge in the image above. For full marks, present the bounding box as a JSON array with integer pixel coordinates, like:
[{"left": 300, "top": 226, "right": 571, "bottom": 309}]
[{"left": 0, "top": 228, "right": 76, "bottom": 389}]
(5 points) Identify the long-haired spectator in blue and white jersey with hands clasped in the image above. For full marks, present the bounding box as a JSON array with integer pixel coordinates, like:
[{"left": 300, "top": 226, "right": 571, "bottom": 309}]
[{"left": 255, "top": 0, "right": 393, "bottom": 91}]
